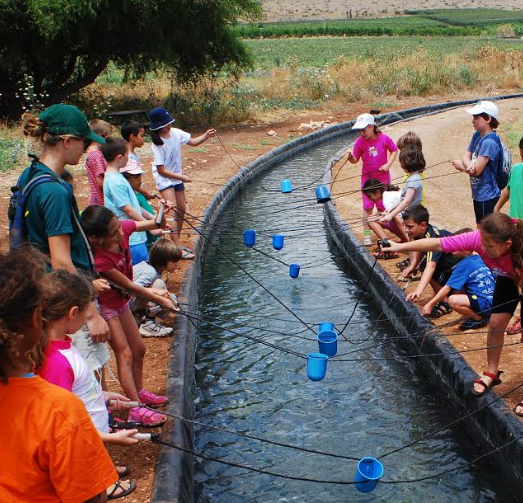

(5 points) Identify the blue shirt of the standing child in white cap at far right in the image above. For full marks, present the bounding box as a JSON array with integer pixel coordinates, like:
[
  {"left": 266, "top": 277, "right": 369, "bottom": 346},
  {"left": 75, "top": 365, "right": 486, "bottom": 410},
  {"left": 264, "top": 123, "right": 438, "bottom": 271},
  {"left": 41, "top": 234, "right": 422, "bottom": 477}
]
[{"left": 467, "top": 131, "right": 501, "bottom": 201}]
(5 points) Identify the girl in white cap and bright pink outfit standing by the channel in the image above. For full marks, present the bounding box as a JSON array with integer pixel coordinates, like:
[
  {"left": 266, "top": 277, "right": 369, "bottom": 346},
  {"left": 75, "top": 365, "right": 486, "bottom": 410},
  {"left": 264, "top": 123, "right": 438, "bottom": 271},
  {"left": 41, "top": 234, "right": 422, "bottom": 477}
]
[{"left": 348, "top": 114, "right": 398, "bottom": 246}]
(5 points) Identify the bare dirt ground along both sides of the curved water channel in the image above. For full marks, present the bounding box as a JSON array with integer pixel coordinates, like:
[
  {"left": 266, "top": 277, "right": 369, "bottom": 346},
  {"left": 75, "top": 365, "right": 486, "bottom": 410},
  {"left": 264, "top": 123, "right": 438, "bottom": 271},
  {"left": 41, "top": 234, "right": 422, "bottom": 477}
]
[{"left": 0, "top": 96, "right": 523, "bottom": 503}]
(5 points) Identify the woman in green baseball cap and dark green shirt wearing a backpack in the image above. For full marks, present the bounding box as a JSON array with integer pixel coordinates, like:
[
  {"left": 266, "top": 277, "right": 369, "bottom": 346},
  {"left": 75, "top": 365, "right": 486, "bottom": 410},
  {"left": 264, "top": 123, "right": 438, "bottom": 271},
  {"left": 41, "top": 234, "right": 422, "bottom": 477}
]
[{"left": 18, "top": 105, "right": 109, "bottom": 371}]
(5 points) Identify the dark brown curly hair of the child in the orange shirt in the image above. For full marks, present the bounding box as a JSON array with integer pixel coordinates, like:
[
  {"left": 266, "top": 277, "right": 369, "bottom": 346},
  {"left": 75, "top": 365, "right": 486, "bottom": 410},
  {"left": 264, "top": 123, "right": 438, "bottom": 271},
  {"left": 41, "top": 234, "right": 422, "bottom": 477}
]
[{"left": 0, "top": 249, "right": 45, "bottom": 384}]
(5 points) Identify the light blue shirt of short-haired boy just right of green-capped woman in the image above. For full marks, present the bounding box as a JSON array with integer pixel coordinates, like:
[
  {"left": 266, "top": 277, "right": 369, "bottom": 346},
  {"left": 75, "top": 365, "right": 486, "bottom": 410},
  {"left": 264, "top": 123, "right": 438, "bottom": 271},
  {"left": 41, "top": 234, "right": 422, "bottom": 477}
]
[{"left": 104, "top": 172, "right": 147, "bottom": 246}]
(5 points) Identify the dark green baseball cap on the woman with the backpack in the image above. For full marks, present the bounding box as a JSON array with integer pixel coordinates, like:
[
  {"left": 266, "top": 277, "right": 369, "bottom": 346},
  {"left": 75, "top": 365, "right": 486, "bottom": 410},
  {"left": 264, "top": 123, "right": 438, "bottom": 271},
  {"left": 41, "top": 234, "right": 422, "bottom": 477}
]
[{"left": 38, "top": 105, "right": 105, "bottom": 143}]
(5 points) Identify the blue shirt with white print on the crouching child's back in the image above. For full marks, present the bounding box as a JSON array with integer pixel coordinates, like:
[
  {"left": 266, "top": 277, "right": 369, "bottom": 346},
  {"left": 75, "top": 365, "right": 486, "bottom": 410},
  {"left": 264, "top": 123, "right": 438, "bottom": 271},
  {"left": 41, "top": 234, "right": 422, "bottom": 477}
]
[{"left": 447, "top": 255, "right": 494, "bottom": 306}]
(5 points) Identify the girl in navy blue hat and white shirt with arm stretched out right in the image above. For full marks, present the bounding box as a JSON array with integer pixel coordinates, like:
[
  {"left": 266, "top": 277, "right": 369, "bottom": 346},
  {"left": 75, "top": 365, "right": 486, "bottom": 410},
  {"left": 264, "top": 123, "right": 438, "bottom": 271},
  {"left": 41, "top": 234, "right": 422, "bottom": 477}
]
[{"left": 147, "top": 107, "right": 216, "bottom": 259}]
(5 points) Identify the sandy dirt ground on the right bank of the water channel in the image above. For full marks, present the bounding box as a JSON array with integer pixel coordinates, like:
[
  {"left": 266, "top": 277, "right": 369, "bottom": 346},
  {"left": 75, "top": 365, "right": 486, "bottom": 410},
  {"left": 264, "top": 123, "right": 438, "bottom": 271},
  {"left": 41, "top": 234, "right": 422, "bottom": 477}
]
[{"left": 332, "top": 99, "right": 523, "bottom": 424}]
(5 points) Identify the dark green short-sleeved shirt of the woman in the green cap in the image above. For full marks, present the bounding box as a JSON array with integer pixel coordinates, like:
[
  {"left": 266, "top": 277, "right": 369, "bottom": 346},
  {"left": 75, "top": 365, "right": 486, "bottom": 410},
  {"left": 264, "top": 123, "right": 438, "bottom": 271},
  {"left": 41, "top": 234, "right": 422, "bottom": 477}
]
[{"left": 18, "top": 162, "right": 90, "bottom": 271}]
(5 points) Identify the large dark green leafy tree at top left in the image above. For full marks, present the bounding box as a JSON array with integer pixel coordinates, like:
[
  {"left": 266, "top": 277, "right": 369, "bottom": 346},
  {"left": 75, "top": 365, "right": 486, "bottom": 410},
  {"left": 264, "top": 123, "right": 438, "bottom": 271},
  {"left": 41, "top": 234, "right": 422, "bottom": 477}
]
[{"left": 0, "top": 0, "right": 261, "bottom": 118}]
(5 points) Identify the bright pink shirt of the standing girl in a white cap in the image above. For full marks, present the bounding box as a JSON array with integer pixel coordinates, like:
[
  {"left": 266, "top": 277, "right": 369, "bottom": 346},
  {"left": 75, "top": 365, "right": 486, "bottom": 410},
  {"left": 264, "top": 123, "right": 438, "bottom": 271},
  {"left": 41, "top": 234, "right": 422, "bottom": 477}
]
[{"left": 352, "top": 133, "right": 398, "bottom": 184}]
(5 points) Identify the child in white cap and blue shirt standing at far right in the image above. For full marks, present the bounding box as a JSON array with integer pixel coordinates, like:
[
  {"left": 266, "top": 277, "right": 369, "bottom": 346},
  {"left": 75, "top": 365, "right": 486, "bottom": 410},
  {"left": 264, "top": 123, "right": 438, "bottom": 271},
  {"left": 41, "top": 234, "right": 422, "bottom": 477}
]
[{"left": 452, "top": 101, "right": 502, "bottom": 227}]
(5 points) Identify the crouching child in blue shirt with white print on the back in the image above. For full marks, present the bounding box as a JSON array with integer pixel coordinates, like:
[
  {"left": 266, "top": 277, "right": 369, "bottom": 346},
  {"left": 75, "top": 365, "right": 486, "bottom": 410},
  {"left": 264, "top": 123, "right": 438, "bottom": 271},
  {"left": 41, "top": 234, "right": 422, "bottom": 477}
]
[{"left": 421, "top": 229, "right": 494, "bottom": 330}]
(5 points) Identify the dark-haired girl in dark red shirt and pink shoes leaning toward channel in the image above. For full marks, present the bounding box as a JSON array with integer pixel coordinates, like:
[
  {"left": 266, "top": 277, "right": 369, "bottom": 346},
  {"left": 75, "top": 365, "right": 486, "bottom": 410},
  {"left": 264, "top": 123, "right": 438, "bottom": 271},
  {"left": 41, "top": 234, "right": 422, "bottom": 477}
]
[{"left": 82, "top": 206, "right": 175, "bottom": 426}]
